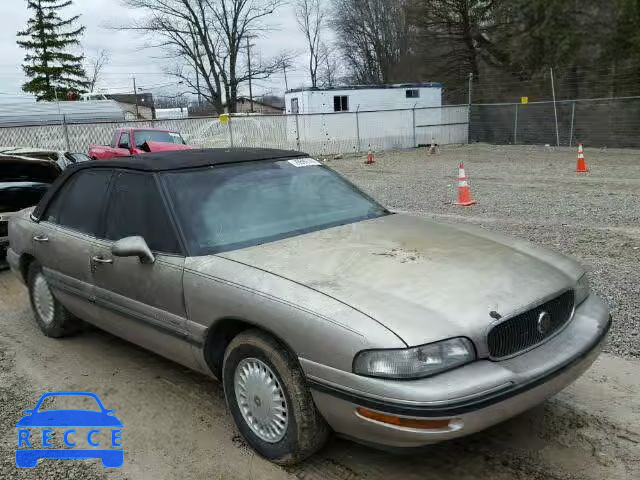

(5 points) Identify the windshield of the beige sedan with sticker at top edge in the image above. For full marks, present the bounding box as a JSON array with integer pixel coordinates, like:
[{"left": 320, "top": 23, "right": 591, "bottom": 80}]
[{"left": 163, "top": 159, "right": 388, "bottom": 255}]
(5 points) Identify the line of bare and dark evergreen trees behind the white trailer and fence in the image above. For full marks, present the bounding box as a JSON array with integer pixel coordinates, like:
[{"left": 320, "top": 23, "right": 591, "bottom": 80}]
[{"left": 327, "top": 0, "right": 640, "bottom": 102}]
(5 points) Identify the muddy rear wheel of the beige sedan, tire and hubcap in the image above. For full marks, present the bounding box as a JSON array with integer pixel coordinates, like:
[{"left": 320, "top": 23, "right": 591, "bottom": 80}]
[{"left": 27, "top": 261, "right": 81, "bottom": 338}]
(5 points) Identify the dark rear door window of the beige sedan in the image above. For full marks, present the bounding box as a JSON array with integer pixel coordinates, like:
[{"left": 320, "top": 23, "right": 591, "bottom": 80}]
[{"left": 45, "top": 169, "right": 113, "bottom": 235}]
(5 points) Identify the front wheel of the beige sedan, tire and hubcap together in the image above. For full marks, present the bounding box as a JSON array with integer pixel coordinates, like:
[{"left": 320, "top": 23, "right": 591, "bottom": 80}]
[{"left": 223, "top": 330, "right": 329, "bottom": 465}]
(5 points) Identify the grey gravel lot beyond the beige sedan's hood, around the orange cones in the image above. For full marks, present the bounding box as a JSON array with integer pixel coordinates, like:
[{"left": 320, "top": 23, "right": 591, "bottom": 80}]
[{"left": 327, "top": 144, "right": 640, "bottom": 358}]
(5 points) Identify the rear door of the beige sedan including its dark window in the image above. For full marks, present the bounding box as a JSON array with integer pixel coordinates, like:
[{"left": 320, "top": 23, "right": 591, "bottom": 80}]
[{"left": 33, "top": 169, "right": 113, "bottom": 323}]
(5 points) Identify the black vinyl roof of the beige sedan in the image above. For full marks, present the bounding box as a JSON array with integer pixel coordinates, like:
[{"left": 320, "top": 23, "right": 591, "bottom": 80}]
[{"left": 32, "top": 148, "right": 308, "bottom": 220}]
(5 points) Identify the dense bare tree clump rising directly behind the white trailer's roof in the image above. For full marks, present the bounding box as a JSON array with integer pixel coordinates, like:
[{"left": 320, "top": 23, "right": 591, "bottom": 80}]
[{"left": 332, "top": 0, "right": 410, "bottom": 84}]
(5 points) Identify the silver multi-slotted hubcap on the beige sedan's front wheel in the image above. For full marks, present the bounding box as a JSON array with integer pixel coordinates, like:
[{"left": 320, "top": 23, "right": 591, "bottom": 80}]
[{"left": 233, "top": 358, "right": 289, "bottom": 443}]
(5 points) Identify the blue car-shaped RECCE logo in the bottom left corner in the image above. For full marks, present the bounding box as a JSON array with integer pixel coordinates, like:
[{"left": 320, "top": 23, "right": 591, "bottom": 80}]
[{"left": 16, "top": 392, "right": 124, "bottom": 468}]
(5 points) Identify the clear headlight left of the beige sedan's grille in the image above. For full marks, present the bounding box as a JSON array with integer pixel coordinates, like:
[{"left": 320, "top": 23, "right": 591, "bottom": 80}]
[{"left": 353, "top": 338, "right": 476, "bottom": 378}]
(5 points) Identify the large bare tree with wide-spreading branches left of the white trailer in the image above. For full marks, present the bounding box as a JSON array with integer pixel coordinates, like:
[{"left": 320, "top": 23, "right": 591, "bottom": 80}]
[{"left": 120, "top": 0, "right": 283, "bottom": 113}]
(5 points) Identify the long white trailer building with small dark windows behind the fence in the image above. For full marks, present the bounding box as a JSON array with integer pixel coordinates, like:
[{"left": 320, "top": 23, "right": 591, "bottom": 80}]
[{"left": 285, "top": 83, "right": 456, "bottom": 152}]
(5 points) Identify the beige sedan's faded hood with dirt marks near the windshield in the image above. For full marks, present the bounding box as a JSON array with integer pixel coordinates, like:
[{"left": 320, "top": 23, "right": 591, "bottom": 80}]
[{"left": 220, "top": 214, "right": 582, "bottom": 345}]
